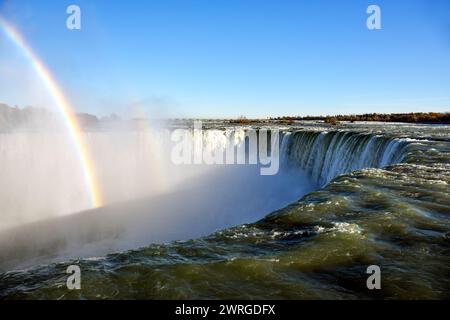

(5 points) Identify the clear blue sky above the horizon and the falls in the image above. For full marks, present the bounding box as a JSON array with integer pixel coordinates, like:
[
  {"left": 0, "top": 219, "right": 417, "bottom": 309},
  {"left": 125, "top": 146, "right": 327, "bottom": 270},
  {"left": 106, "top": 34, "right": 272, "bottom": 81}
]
[{"left": 0, "top": 0, "right": 450, "bottom": 117}]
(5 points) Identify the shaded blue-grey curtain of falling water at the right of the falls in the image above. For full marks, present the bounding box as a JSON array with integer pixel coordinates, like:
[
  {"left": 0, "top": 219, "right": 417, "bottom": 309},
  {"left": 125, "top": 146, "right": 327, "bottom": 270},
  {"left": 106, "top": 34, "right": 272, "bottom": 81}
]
[{"left": 281, "top": 131, "right": 408, "bottom": 186}]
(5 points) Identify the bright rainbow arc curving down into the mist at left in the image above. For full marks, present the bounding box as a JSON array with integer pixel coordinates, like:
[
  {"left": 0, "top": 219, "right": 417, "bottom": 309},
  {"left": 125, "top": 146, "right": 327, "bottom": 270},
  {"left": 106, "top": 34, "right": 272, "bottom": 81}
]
[{"left": 0, "top": 17, "right": 102, "bottom": 208}]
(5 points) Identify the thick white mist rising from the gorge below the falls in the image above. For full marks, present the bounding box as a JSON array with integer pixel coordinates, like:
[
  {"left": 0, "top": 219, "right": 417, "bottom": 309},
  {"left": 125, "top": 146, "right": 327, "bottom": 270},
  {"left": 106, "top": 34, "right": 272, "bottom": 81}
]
[{"left": 0, "top": 114, "right": 315, "bottom": 270}]
